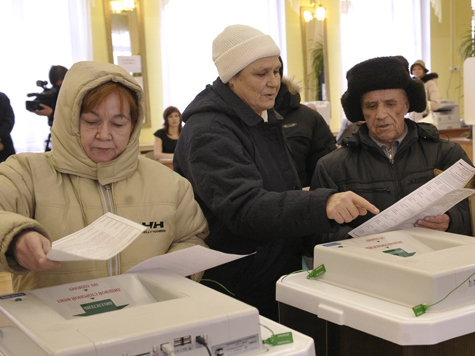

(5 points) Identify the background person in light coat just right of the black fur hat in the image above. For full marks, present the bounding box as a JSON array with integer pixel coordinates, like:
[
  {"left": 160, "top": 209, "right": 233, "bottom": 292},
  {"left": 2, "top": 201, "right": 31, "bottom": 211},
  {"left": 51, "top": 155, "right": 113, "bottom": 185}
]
[{"left": 410, "top": 59, "right": 440, "bottom": 123}]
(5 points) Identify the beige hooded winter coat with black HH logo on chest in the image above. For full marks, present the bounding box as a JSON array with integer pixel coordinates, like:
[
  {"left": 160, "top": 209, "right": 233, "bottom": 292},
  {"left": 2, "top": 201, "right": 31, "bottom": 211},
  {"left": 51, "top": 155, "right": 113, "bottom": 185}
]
[{"left": 0, "top": 62, "right": 208, "bottom": 291}]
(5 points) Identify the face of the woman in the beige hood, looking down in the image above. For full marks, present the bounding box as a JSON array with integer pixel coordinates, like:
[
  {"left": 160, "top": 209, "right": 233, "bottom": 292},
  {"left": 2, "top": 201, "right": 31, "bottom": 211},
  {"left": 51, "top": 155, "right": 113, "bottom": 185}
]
[{"left": 79, "top": 93, "right": 133, "bottom": 163}]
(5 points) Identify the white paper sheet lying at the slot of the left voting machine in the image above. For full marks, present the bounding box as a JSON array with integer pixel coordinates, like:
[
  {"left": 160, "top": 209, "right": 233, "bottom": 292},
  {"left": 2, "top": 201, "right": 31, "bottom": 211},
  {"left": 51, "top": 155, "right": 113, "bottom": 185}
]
[{"left": 126, "top": 245, "right": 255, "bottom": 277}]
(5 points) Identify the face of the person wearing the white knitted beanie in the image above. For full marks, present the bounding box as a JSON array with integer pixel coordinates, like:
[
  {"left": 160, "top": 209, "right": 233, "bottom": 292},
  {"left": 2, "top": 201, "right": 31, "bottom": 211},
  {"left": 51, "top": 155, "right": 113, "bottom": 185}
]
[{"left": 229, "top": 56, "right": 280, "bottom": 115}]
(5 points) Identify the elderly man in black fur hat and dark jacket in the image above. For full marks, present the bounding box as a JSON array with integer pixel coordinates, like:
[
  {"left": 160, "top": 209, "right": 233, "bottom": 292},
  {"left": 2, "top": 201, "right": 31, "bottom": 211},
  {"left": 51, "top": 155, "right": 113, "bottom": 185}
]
[{"left": 311, "top": 56, "right": 472, "bottom": 240}]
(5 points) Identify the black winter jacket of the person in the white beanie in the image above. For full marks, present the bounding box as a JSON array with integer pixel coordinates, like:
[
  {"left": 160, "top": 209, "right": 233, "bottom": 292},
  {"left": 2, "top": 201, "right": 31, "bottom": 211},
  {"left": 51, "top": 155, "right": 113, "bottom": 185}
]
[{"left": 174, "top": 78, "right": 337, "bottom": 320}]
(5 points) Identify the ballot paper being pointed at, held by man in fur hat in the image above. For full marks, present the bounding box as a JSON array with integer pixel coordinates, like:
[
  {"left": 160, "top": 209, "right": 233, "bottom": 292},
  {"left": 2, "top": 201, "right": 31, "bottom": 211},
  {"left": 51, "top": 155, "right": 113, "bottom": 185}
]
[{"left": 349, "top": 159, "right": 475, "bottom": 237}]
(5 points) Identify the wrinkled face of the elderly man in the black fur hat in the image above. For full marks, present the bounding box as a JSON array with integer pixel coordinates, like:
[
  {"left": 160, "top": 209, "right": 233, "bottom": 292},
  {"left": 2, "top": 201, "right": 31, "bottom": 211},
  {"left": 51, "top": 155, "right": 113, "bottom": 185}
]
[{"left": 361, "top": 89, "right": 409, "bottom": 148}]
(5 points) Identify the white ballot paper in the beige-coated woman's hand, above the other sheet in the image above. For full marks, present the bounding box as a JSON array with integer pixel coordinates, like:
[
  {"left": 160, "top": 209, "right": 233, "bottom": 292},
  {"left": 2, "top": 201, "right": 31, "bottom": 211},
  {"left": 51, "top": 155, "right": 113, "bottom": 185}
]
[{"left": 46, "top": 213, "right": 147, "bottom": 261}]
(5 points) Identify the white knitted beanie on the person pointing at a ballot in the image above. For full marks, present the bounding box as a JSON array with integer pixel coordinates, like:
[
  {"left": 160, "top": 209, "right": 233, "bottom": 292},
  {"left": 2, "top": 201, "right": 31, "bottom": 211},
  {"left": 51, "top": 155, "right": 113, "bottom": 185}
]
[{"left": 213, "top": 25, "right": 280, "bottom": 84}]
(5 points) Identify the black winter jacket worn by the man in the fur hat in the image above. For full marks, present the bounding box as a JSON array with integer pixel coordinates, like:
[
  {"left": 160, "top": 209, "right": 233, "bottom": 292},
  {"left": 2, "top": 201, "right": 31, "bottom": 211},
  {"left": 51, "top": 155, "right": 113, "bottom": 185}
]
[{"left": 311, "top": 119, "right": 472, "bottom": 239}]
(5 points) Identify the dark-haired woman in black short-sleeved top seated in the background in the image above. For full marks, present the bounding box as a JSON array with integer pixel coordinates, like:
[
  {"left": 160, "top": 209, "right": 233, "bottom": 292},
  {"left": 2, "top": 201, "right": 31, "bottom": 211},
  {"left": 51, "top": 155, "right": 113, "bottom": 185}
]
[{"left": 153, "top": 106, "right": 182, "bottom": 168}]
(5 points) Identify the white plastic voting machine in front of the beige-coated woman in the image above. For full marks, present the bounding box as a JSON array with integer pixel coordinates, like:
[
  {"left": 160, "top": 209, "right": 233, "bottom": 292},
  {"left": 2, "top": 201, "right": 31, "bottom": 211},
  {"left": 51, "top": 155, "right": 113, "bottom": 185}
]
[{"left": 0, "top": 269, "right": 315, "bottom": 356}]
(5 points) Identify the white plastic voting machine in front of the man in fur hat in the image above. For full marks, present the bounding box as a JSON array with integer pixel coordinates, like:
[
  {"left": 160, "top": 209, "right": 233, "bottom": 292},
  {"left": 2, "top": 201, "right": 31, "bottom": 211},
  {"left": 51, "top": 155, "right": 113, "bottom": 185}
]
[{"left": 277, "top": 228, "right": 475, "bottom": 345}]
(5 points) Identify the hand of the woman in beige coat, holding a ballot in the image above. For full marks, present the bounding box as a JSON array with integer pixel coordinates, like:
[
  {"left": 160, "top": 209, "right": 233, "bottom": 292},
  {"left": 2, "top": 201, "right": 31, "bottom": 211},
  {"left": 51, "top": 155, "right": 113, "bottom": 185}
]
[{"left": 9, "top": 231, "right": 61, "bottom": 272}]
